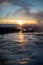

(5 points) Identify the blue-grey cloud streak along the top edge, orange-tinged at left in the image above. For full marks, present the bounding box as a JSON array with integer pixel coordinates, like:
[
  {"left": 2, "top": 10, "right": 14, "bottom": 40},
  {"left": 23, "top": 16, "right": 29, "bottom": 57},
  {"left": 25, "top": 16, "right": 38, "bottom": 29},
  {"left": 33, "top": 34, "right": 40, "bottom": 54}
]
[{"left": 0, "top": 0, "right": 31, "bottom": 7}]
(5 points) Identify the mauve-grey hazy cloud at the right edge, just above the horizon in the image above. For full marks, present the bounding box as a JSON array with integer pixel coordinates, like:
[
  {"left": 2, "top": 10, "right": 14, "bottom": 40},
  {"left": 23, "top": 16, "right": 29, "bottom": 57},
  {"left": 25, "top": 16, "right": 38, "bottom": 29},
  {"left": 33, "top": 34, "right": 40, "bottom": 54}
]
[{"left": 31, "top": 11, "right": 43, "bottom": 25}]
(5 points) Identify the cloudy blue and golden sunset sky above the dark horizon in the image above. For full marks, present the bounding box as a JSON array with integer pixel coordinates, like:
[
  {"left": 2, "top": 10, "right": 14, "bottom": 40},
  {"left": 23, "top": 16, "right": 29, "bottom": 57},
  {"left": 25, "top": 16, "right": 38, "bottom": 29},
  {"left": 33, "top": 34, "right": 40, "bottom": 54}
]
[{"left": 0, "top": 0, "right": 43, "bottom": 24}]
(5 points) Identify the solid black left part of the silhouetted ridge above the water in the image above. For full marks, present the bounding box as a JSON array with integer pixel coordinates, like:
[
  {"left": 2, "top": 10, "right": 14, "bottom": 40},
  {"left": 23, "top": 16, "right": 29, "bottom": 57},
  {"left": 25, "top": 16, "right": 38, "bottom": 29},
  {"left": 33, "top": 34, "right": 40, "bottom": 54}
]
[{"left": 0, "top": 27, "right": 20, "bottom": 33}]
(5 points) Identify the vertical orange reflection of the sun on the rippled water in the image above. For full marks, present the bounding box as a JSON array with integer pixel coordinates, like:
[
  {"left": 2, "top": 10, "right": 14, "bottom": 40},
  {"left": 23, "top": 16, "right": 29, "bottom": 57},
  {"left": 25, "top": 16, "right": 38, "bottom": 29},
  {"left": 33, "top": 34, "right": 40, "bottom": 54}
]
[{"left": 17, "top": 32, "right": 27, "bottom": 54}]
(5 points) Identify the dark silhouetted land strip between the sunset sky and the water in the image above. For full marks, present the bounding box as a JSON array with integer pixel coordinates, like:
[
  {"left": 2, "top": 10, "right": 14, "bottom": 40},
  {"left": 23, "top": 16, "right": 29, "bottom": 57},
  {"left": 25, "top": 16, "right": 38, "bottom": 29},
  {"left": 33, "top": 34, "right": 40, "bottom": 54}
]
[{"left": 0, "top": 24, "right": 40, "bottom": 34}]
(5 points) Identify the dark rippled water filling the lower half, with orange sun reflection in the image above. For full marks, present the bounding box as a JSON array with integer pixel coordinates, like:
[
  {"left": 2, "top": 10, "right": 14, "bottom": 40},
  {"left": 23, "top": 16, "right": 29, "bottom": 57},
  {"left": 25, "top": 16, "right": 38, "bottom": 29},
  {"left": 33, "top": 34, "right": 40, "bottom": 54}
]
[{"left": 0, "top": 32, "right": 43, "bottom": 65}]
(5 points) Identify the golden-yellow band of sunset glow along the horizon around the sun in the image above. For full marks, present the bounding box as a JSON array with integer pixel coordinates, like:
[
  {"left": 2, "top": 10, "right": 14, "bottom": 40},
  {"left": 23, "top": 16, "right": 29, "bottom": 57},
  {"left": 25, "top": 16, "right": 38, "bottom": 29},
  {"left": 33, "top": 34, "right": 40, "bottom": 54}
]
[{"left": 0, "top": 19, "right": 38, "bottom": 26}]
